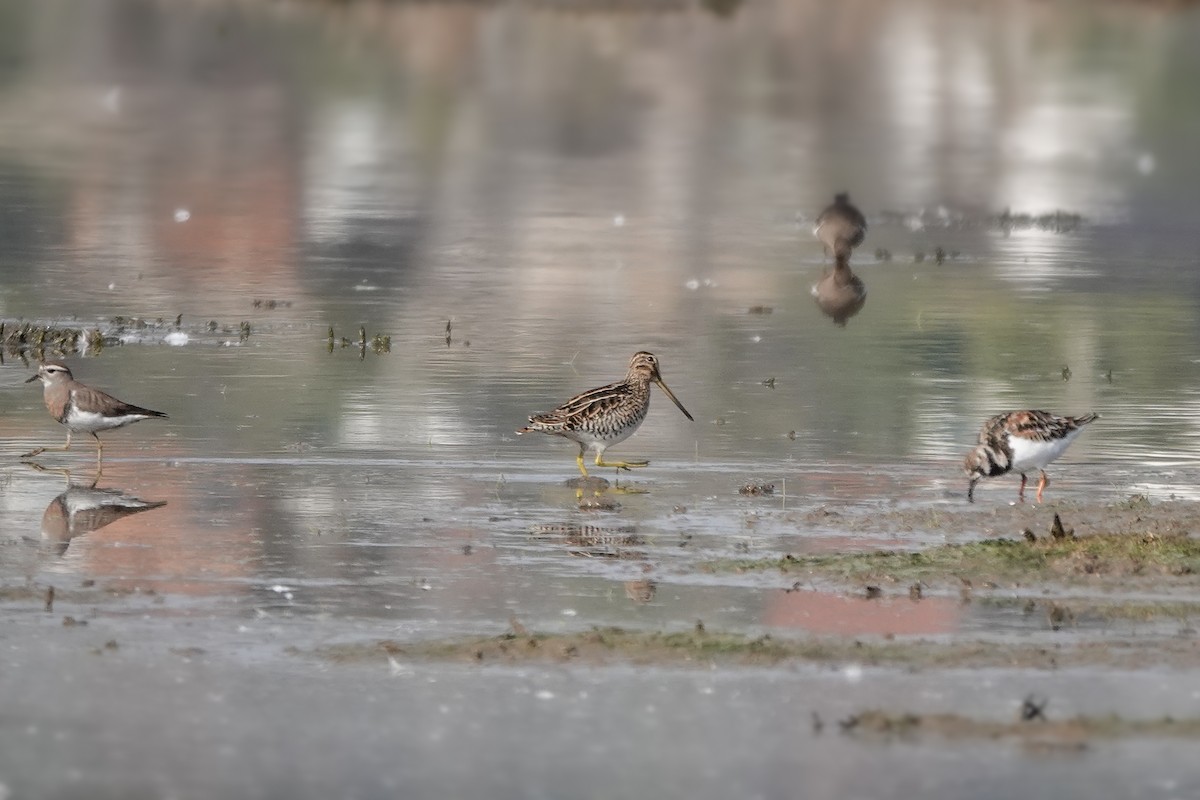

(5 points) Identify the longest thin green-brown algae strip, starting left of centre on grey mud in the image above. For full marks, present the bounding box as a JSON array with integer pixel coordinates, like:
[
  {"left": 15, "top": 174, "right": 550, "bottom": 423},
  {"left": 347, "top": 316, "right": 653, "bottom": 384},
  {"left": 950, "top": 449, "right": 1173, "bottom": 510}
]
[{"left": 304, "top": 626, "right": 1200, "bottom": 669}]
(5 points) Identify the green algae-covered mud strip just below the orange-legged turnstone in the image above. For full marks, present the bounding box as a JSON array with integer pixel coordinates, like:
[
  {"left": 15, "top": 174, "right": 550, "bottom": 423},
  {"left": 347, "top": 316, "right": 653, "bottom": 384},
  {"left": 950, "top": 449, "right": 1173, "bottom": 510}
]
[{"left": 698, "top": 534, "right": 1200, "bottom": 585}]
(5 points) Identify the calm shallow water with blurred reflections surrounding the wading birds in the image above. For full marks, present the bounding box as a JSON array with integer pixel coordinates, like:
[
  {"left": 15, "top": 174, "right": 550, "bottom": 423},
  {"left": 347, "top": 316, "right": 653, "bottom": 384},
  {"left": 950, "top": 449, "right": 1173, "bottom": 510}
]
[{"left": 0, "top": 1, "right": 1200, "bottom": 796}]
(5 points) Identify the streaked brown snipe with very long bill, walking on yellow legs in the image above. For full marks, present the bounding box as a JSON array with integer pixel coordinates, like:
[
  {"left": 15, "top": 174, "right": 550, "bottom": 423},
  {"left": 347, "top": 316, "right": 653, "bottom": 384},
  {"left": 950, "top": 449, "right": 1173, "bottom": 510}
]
[{"left": 517, "top": 350, "right": 695, "bottom": 476}]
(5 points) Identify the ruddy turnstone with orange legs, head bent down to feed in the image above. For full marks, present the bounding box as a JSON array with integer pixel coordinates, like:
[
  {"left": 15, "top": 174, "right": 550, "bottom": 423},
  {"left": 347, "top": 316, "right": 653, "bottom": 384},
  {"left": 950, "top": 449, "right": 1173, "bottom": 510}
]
[{"left": 964, "top": 410, "right": 1098, "bottom": 503}]
